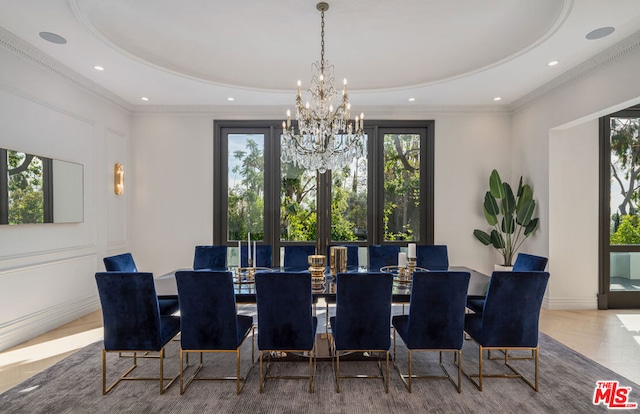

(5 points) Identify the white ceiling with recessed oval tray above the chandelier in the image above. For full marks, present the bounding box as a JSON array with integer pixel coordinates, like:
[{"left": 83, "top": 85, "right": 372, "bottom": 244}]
[{"left": 0, "top": 0, "right": 640, "bottom": 106}]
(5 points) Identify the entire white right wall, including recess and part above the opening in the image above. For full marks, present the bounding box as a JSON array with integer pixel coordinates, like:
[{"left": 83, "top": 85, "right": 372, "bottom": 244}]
[{"left": 511, "top": 43, "right": 640, "bottom": 309}]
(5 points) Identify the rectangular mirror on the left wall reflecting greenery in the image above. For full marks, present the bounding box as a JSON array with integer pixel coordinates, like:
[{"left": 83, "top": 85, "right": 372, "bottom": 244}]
[{"left": 0, "top": 148, "right": 84, "bottom": 224}]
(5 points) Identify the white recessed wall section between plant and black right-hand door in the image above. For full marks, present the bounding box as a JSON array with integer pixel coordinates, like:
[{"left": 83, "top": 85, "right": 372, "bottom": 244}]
[{"left": 547, "top": 120, "right": 599, "bottom": 309}]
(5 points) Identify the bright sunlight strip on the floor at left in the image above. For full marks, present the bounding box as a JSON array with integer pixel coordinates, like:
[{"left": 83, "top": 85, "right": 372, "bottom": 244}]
[{"left": 0, "top": 328, "right": 103, "bottom": 371}]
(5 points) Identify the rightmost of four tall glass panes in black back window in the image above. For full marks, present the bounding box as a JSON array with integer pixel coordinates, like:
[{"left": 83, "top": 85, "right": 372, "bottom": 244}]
[{"left": 383, "top": 134, "right": 420, "bottom": 241}]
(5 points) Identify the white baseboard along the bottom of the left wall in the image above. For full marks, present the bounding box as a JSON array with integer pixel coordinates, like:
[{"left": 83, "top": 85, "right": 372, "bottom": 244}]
[{"left": 0, "top": 296, "right": 100, "bottom": 351}]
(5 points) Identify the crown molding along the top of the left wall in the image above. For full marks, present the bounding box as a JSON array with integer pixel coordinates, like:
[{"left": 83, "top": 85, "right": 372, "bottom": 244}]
[{"left": 0, "top": 27, "right": 133, "bottom": 111}]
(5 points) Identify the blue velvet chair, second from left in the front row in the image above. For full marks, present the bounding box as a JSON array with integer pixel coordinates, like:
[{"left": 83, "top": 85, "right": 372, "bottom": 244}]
[{"left": 176, "top": 270, "right": 254, "bottom": 394}]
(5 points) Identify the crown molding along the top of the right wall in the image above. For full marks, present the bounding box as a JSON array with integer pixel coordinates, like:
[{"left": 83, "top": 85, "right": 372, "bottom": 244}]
[{"left": 507, "top": 31, "right": 640, "bottom": 112}]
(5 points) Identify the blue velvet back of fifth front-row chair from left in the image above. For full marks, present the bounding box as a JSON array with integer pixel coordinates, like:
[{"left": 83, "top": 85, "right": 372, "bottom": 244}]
[{"left": 403, "top": 271, "right": 471, "bottom": 349}]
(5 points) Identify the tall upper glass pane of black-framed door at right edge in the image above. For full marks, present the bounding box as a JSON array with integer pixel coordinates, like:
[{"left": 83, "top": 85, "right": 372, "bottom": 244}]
[{"left": 610, "top": 117, "right": 640, "bottom": 246}]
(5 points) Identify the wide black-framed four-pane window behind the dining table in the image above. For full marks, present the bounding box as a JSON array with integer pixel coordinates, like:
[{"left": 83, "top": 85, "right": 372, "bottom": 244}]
[{"left": 213, "top": 121, "right": 434, "bottom": 263}]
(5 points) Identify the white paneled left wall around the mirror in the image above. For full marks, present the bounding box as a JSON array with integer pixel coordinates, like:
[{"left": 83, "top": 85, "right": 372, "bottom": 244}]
[{"left": 0, "top": 48, "right": 130, "bottom": 350}]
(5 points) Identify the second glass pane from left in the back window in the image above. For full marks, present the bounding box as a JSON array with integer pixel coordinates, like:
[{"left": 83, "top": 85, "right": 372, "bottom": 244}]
[{"left": 280, "top": 137, "right": 317, "bottom": 241}]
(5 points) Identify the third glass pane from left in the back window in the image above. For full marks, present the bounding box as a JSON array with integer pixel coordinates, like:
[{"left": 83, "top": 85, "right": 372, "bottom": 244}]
[{"left": 331, "top": 136, "right": 368, "bottom": 241}]
